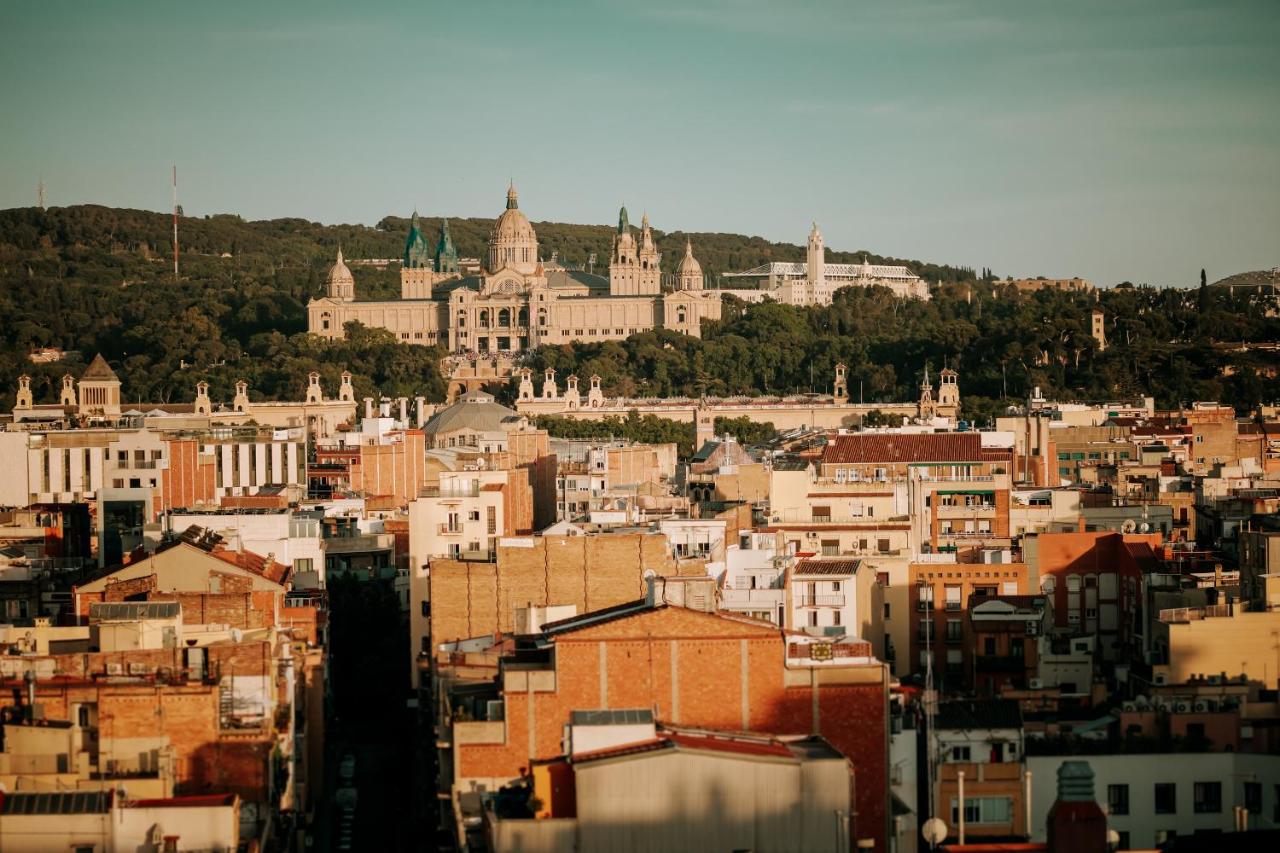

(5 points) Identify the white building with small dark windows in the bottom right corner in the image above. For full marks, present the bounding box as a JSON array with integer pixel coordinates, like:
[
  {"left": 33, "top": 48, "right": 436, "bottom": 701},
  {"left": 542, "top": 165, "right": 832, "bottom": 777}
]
[{"left": 1027, "top": 752, "right": 1280, "bottom": 849}]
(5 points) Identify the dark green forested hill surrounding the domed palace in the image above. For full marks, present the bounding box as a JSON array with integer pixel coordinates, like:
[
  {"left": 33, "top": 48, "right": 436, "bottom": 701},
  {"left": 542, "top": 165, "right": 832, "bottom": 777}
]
[{"left": 0, "top": 206, "right": 1280, "bottom": 418}]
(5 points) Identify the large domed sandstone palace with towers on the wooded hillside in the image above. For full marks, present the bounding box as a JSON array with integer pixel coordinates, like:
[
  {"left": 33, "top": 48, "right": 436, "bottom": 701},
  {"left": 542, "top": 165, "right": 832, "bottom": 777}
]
[{"left": 307, "top": 186, "right": 721, "bottom": 355}]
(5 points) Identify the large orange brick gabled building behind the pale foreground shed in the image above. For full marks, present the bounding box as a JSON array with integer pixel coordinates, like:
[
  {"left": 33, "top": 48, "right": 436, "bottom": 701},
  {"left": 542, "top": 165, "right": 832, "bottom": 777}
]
[{"left": 452, "top": 601, "right": 888, "bottom": 849}]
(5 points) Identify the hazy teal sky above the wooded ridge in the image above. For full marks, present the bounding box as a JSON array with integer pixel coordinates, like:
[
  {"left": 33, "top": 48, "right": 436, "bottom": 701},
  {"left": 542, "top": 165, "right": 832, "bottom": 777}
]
[{"left": 0, "top": 0, "right": 1280, "bottom": 284}]
